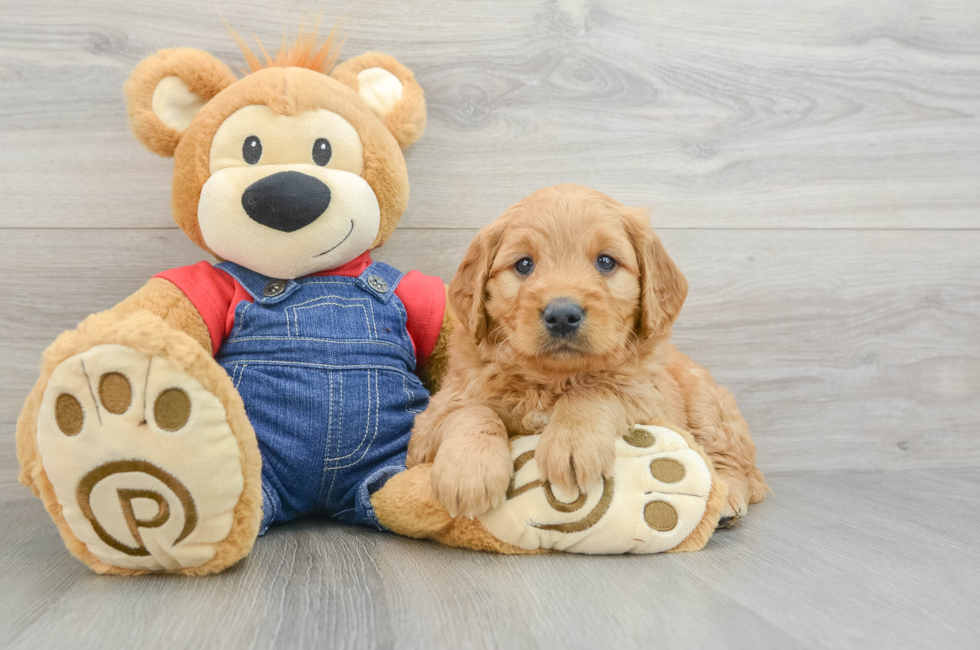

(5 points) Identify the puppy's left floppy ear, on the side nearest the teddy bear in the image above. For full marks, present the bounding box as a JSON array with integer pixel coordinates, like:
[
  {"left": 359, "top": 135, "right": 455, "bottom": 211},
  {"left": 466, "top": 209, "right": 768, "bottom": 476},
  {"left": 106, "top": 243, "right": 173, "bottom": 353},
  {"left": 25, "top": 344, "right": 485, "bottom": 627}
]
[{"left": 449, "top": 223, "right": 503, "bottom": 340}]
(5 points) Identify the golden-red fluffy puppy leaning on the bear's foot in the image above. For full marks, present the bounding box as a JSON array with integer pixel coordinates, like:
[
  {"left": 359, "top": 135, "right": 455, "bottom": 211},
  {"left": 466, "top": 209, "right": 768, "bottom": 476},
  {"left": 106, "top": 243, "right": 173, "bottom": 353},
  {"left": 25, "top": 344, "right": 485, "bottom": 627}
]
[{"left": 408, "top": 185, "right": 766, "bottom": 525}]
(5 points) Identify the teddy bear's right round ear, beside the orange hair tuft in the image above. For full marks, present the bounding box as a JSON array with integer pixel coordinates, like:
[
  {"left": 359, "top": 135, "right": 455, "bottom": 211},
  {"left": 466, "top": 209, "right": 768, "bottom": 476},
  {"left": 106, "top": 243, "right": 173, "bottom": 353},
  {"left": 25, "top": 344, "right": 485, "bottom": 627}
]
[{"left": 330, "top": 52, "right": 425, "bottom": 149}]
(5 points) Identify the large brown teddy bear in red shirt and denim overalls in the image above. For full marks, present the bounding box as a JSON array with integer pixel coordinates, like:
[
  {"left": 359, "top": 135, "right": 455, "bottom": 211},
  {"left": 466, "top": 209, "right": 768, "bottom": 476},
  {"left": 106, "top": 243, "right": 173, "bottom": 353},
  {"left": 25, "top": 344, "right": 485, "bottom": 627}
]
[{"left": 11, "top": 29, "right": 725, "bottom": 575}]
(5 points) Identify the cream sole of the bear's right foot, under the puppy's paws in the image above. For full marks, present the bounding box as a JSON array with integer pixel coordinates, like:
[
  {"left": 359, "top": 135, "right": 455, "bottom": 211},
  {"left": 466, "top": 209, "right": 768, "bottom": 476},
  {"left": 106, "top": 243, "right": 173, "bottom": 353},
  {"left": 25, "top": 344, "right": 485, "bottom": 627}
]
[{"left": 478, "top": 426, "right": 727, "bottom": 554}]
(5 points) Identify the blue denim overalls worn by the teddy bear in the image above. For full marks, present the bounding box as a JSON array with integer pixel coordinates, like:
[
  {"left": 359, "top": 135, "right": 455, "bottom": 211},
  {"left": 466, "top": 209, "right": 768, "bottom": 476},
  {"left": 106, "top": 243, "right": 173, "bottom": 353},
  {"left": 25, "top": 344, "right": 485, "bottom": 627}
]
[{"left": 215, "top": 262, "right": 429, "bottom": 532}]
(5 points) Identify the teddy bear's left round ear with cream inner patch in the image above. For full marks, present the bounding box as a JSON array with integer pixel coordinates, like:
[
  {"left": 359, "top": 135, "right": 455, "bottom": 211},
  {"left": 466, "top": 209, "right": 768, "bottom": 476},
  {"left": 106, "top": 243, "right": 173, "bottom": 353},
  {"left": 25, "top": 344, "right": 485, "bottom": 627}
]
[{"left": 124, "top": 48, "right": 236, "bottom": 156}]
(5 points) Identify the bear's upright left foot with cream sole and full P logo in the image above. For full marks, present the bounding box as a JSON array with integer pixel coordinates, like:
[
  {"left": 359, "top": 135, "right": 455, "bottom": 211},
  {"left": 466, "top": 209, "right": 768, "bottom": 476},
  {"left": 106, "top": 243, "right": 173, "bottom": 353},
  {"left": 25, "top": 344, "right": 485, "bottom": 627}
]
[{"left": 26, "top": 334, "right": 261, "bottom": 574}]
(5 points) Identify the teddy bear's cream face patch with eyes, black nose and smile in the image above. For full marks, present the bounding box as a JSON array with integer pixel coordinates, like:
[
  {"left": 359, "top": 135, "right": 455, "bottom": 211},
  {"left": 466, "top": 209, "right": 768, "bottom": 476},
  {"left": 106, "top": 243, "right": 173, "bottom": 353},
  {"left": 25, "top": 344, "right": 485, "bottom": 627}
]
[{"left": 198, "top": 106, "right": 381, "bottom": 279}]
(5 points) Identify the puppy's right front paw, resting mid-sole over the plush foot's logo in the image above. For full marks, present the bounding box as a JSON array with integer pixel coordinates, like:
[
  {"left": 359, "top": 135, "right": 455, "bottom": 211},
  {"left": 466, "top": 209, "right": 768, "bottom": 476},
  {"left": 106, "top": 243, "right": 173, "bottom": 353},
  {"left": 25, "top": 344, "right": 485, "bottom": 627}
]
[{"left": 534, "top": 430, "right": 616, "bottom": 495}]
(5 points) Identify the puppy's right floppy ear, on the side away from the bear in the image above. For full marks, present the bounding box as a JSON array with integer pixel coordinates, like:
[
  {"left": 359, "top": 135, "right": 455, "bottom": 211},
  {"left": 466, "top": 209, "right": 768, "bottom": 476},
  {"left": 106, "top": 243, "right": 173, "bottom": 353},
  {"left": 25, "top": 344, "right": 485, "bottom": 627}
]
[{"left": 622, "top": 208, "right": 687, "bottom": 339}]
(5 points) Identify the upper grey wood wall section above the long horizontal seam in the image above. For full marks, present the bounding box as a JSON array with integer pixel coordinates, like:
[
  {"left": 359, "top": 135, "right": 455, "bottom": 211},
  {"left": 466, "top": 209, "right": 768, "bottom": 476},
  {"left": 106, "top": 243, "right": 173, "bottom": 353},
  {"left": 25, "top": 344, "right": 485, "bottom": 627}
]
[{"left": 0, "top": 0, "right": 980, "bottom": 228}]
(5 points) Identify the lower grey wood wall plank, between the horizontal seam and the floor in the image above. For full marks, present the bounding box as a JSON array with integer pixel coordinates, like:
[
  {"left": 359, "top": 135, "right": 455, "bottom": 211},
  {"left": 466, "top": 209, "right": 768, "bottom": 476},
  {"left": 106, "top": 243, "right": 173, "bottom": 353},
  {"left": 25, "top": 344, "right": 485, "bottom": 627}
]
[{"left": 0, "top": 230, "right": 980, "bottom": 472}]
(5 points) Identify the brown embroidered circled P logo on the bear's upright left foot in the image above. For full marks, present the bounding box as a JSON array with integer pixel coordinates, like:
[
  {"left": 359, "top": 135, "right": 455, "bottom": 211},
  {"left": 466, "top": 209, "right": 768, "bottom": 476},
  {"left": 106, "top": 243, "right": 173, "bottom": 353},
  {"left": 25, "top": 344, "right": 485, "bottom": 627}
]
[{"left": 76, "top": 460, "right": 197, "bottom": 557}]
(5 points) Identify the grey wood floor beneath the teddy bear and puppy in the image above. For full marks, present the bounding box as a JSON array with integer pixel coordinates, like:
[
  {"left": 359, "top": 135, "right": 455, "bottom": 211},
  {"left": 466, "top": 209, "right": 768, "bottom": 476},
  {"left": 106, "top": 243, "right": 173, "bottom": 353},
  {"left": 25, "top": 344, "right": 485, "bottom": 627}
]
[{"left": 0, "top": 470, "right": 980, "bottom": 649}]
